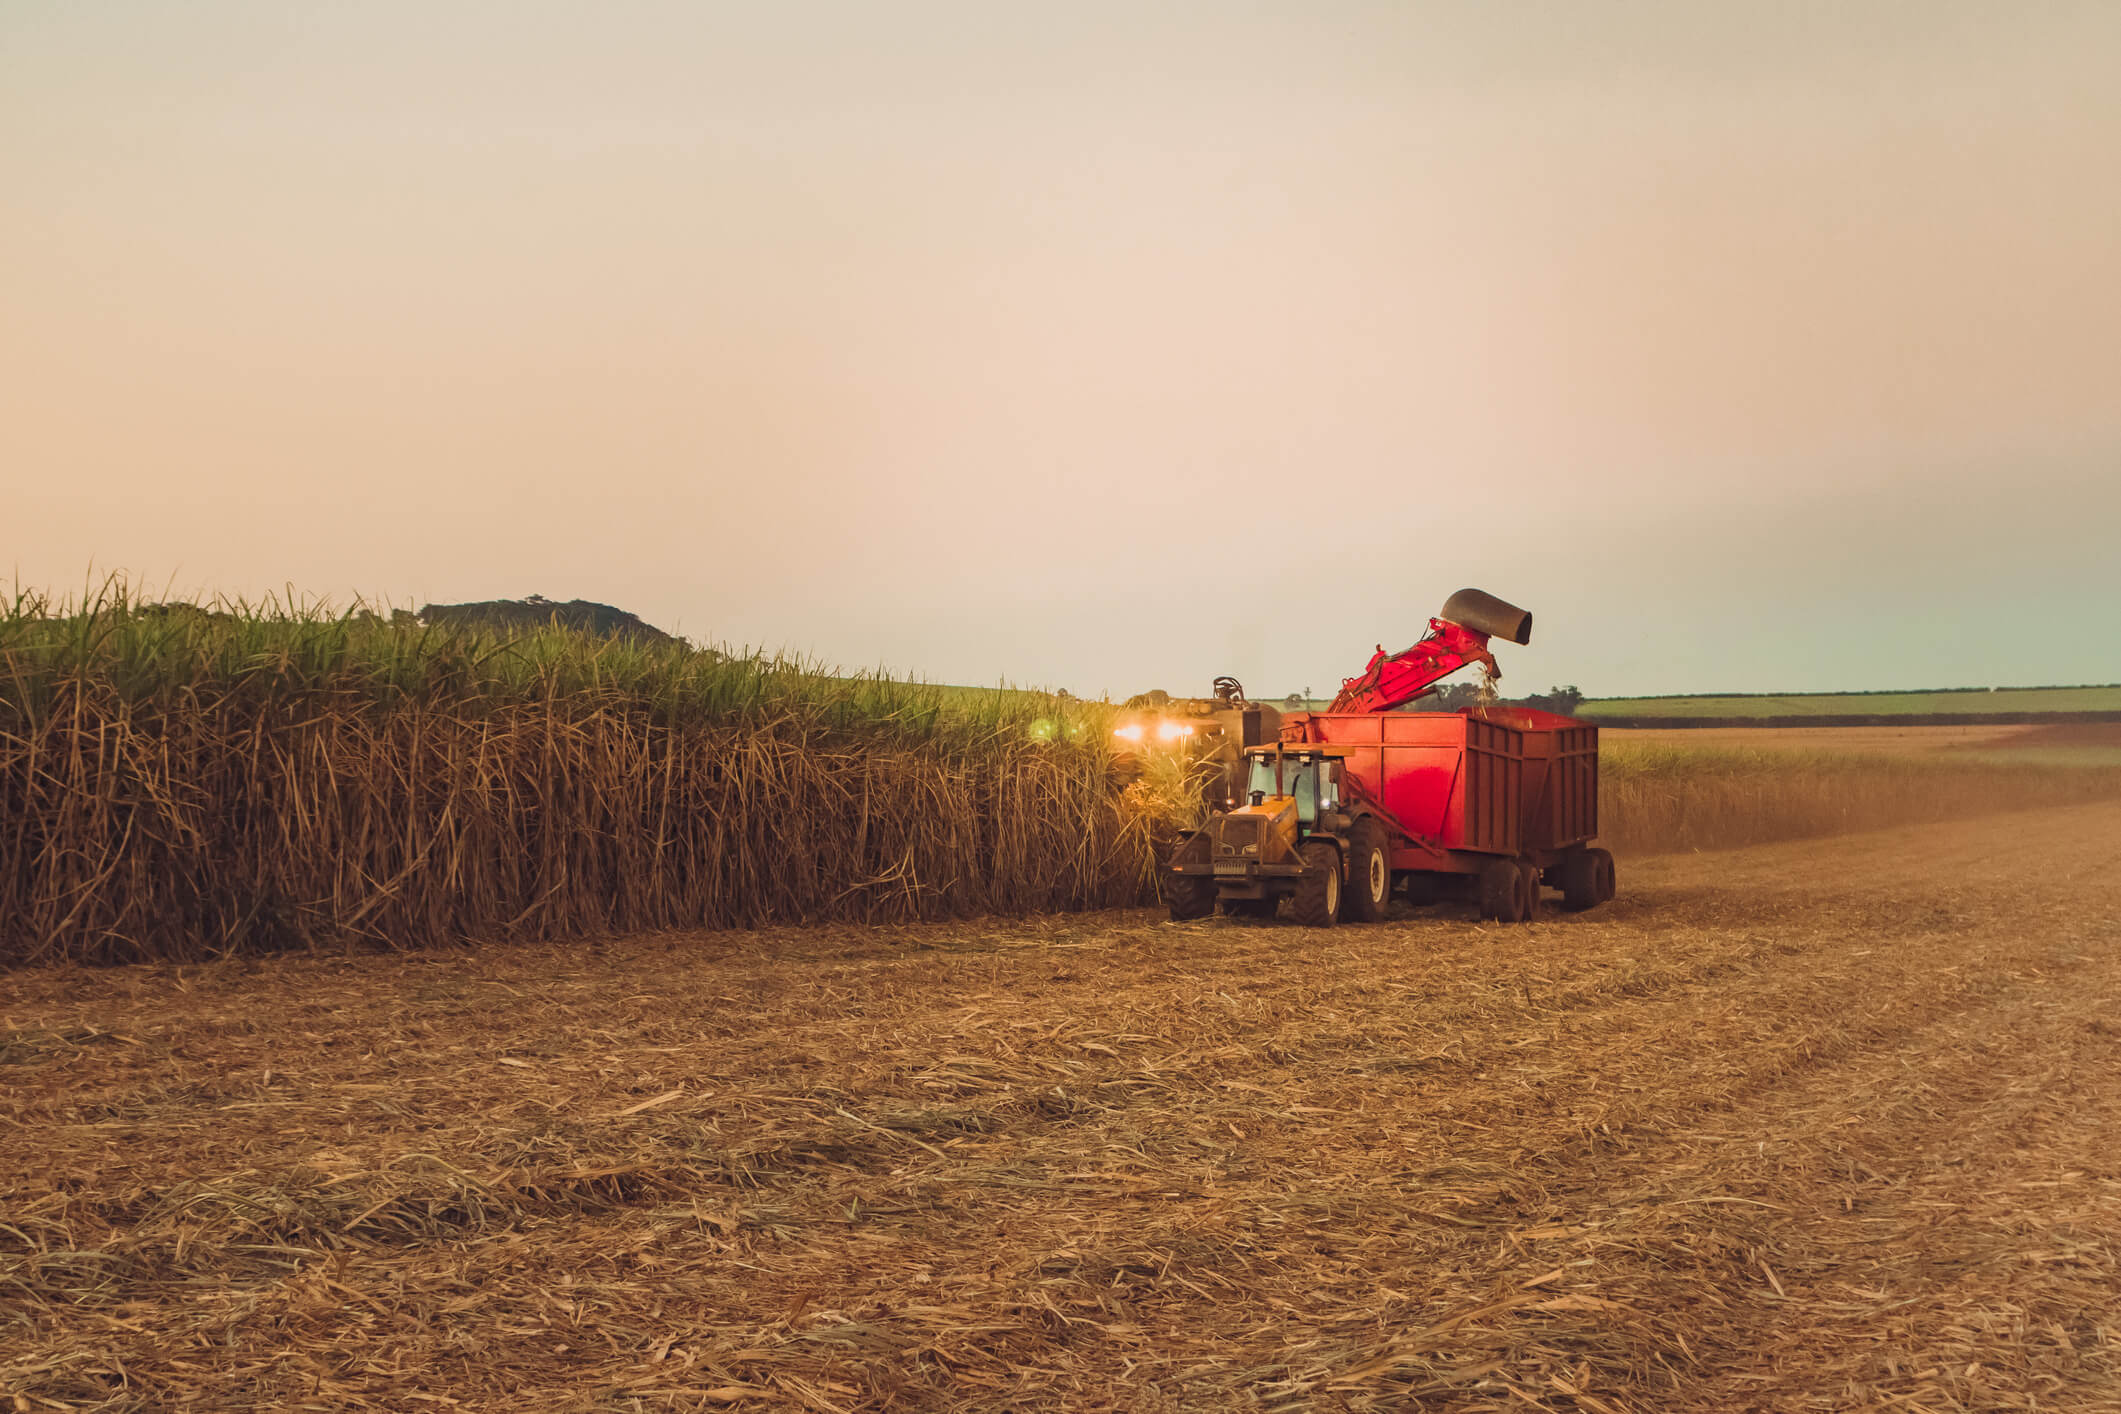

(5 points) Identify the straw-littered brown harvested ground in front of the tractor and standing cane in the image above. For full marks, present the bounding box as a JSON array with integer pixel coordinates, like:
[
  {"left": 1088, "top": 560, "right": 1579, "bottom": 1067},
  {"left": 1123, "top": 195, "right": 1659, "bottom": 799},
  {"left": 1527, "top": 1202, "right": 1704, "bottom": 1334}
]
[{"left": 0, "top": 803, "right": 2121, "bottom": 1414}]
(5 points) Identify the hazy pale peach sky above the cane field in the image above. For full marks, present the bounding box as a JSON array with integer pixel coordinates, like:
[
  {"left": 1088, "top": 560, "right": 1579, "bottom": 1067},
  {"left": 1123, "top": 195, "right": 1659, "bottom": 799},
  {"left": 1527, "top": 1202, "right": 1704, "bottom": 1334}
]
[{"left": 0, "top": 0, "right": 2121, "bottom": 695}]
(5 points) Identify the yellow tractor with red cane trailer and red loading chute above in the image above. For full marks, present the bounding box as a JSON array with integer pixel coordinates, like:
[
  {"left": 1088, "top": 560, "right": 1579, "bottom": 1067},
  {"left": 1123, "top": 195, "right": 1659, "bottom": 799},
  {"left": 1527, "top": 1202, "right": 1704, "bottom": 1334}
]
[{"left": 1164, "top": 589, "right": 1614, "bottom": 926}]
